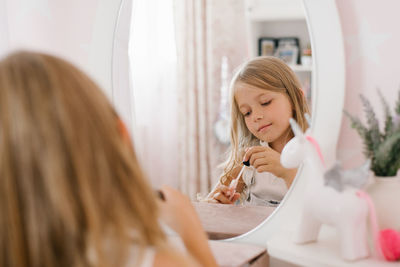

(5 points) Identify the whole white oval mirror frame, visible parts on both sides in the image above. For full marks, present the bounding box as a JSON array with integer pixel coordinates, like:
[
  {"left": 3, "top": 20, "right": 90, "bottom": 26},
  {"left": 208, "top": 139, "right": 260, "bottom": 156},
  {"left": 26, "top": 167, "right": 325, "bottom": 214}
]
[{"left": 111, "top": 0, "right": 345, "bottom": 246}]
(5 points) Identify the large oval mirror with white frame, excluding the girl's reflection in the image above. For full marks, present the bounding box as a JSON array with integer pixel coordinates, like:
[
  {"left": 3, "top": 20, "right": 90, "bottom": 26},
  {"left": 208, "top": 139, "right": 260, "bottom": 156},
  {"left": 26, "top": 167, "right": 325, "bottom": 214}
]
[{"left": 112, "top": 0, "right": 344, "bottom": 245}]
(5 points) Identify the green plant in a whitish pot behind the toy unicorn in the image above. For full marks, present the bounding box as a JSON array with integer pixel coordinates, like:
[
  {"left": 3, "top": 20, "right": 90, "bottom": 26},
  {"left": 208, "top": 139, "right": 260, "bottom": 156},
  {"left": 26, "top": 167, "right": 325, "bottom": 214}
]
[{"left": 344, "top": 91, "right": 400, "bottom": 230}]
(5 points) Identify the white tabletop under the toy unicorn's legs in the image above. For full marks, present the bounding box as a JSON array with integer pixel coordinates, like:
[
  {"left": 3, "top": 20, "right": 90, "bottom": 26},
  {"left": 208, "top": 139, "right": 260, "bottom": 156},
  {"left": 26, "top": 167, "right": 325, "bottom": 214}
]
[{"left": 267, "top": 226, "right": 399, "bottom": 267}]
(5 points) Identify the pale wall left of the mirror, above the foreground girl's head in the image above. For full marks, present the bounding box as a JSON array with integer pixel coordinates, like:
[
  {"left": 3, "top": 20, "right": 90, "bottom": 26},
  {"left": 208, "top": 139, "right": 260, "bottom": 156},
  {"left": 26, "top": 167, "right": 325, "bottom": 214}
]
[{"left": 0, "top": 0, "right": 121, "bottom": 97}]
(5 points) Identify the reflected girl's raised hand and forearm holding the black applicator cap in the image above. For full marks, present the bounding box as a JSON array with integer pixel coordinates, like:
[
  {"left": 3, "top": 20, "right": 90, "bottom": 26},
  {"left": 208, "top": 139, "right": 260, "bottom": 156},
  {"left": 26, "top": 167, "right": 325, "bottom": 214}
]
[{"left": 243, "top": 146, "right": 297, "bottom": 187}]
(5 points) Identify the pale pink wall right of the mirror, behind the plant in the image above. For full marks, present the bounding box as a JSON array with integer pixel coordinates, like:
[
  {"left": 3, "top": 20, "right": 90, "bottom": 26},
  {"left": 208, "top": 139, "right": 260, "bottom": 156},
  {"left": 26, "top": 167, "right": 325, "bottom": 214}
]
[{"left": 336, "top": 0, "right": 400, "bottom": 167}]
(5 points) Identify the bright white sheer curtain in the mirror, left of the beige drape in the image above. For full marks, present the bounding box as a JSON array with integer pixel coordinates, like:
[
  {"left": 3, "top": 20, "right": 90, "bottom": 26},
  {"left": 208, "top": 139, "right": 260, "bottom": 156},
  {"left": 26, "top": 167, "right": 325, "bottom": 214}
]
[{"left": 129, "top": 0, "right": 178, "bottom": 187}]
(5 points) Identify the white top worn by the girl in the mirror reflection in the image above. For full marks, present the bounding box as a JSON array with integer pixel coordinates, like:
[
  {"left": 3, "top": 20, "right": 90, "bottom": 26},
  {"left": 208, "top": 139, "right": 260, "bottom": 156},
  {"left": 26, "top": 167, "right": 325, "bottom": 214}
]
[{"left": 242, "top": 141, "right": 288, "bottom": 206}]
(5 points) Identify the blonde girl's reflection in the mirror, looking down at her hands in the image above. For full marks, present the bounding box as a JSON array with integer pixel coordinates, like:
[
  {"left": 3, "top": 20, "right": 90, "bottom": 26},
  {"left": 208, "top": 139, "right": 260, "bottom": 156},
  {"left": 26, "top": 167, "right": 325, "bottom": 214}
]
[{"left": 207, "top": 57, "right": 309, "bottom": 206}]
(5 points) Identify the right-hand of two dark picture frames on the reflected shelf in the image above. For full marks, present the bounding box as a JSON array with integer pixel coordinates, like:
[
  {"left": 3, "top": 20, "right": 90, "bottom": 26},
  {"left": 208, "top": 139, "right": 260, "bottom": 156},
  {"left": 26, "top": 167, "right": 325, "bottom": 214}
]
[{"left": 274, "top": 37, "right": 300, "bottom": 65}]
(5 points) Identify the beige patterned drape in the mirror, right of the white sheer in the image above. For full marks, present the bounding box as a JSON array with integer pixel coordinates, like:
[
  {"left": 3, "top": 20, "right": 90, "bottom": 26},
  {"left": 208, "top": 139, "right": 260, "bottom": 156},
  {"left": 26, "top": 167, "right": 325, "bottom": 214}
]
[{"left": 175, "top": 0, "right": 213, "bottom": 198}]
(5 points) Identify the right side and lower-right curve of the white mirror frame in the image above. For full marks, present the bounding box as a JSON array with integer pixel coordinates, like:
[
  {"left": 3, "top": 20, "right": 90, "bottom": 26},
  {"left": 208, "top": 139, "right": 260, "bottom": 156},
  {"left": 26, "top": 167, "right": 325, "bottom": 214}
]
[{"left": 226, "top": 0, "right": 345, "bottom": 246}]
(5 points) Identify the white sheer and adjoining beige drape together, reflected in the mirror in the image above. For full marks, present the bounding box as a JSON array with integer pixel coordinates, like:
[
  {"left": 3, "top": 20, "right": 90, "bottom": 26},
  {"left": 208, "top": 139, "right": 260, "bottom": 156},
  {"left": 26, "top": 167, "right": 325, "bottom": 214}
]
[{"left": 130, "top": 0, "right": 211, "bottom": 199}]
